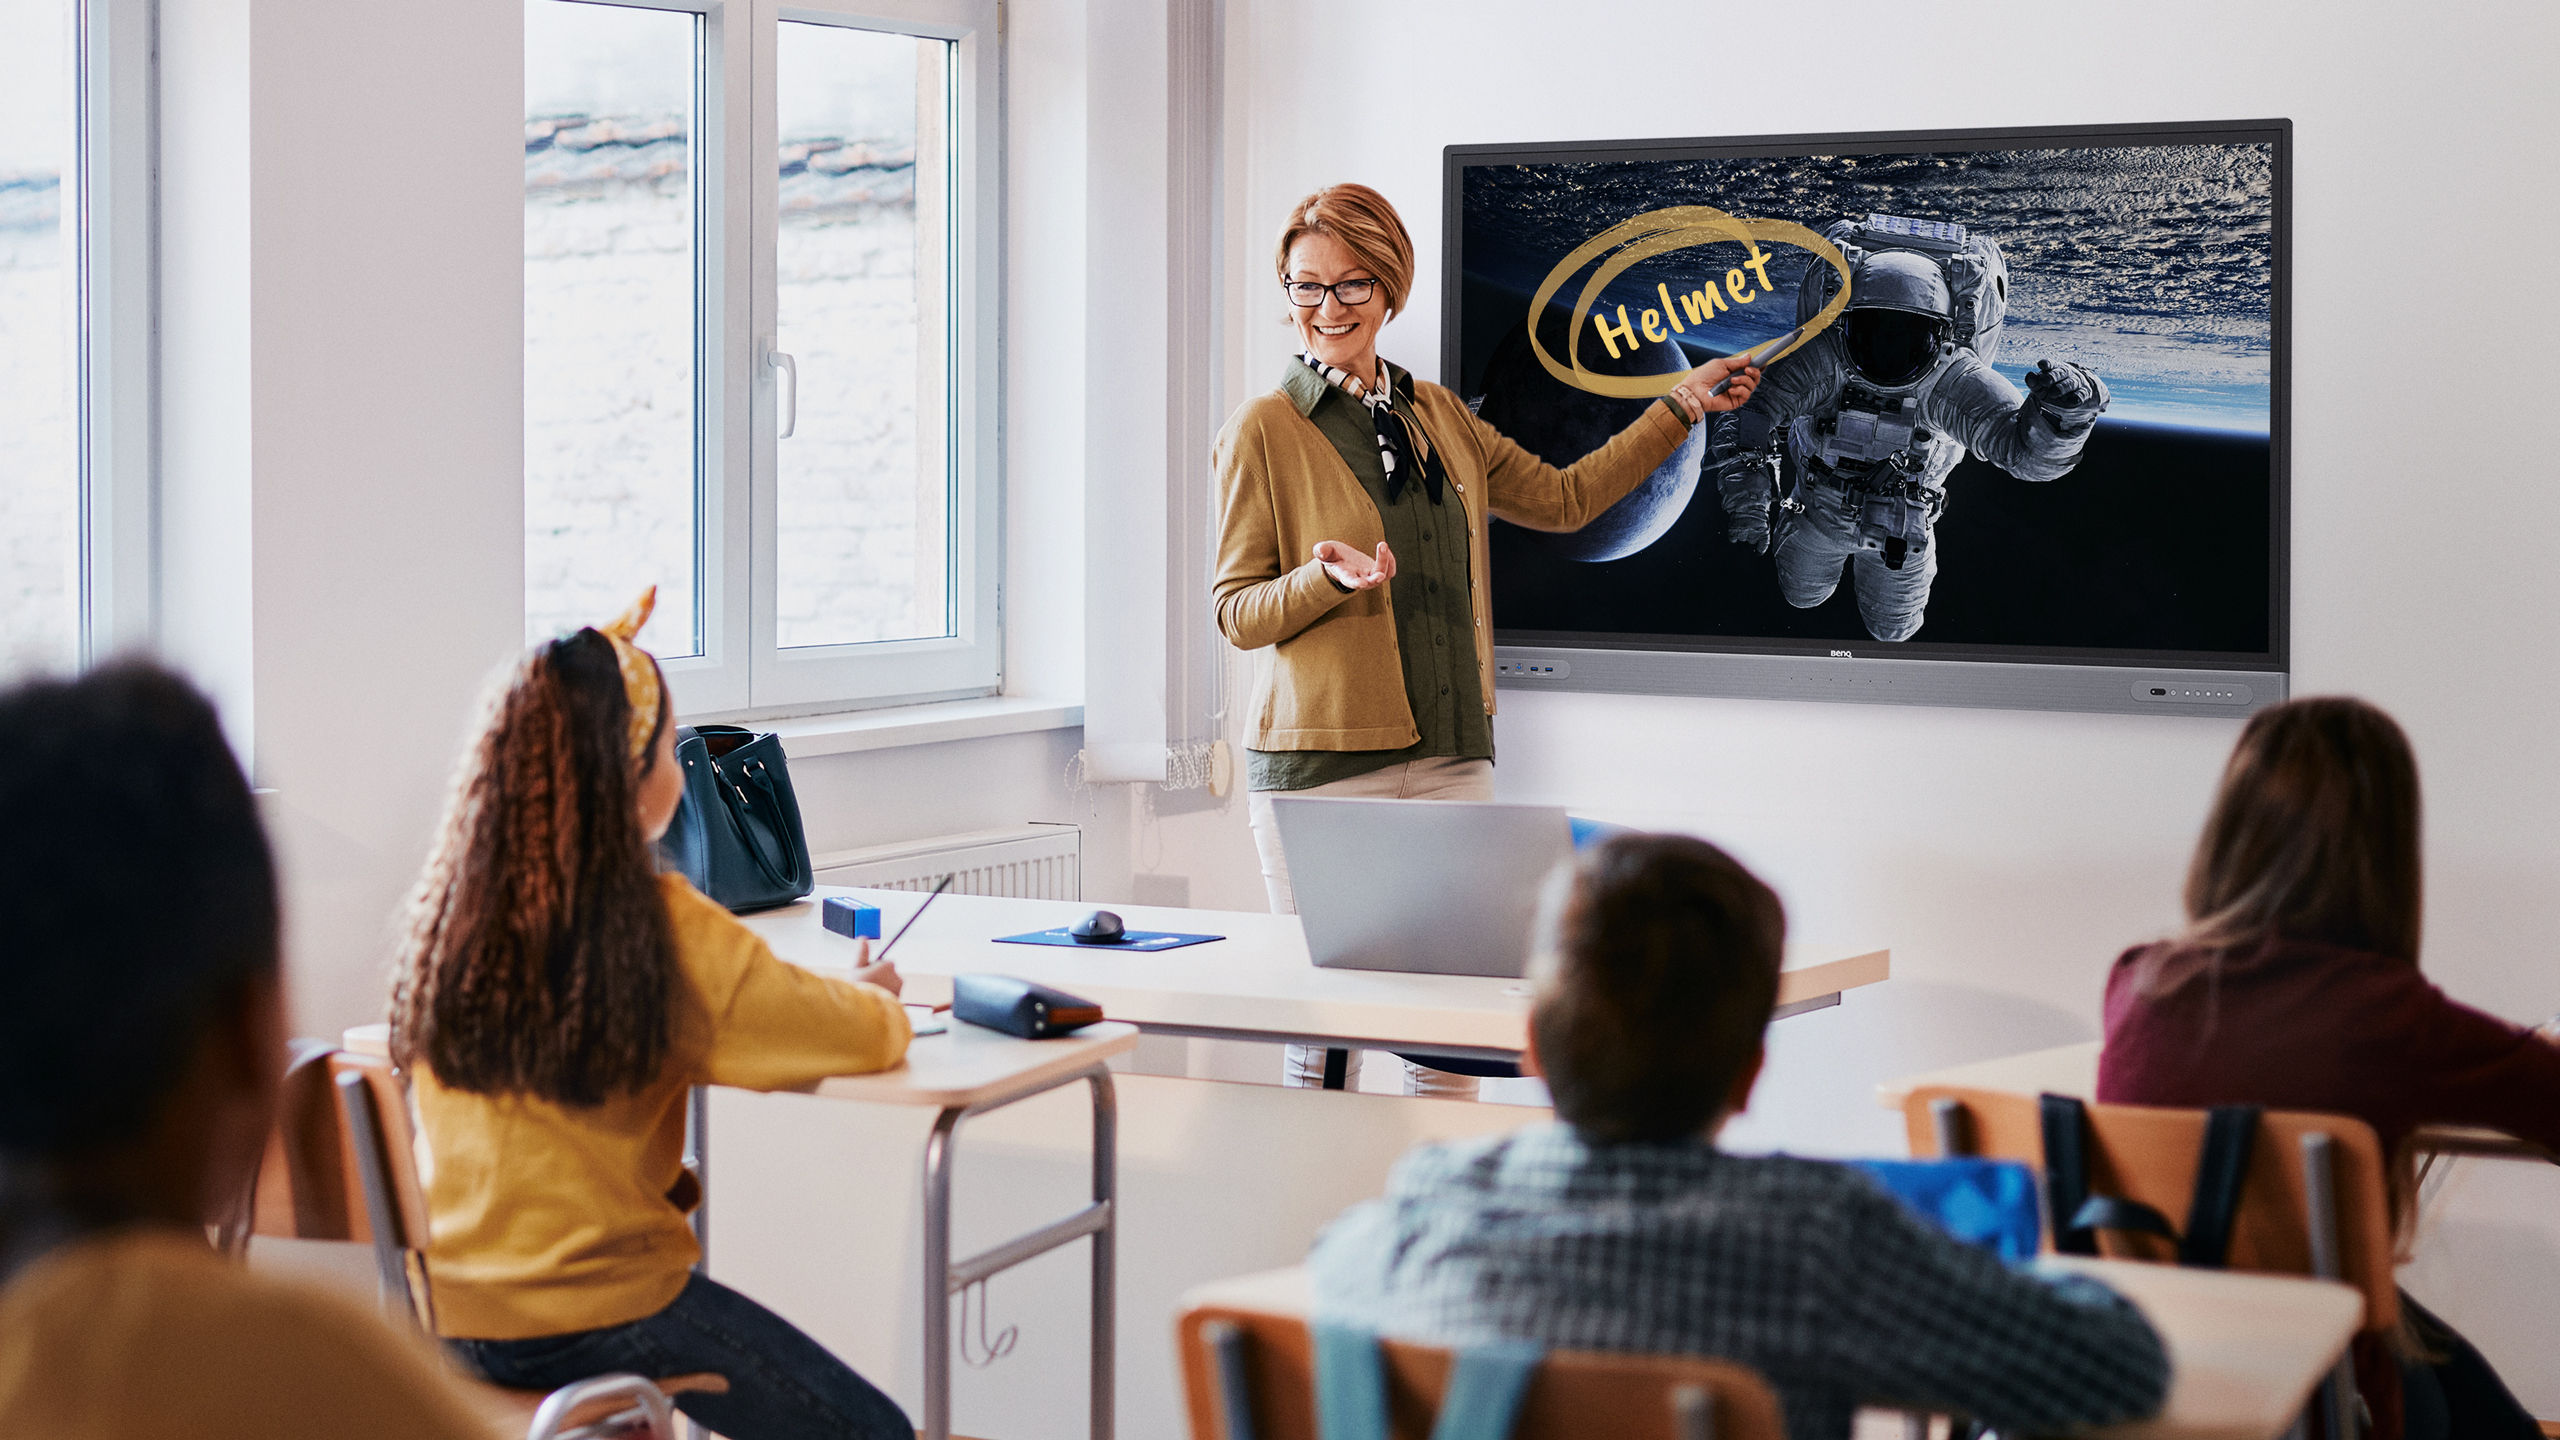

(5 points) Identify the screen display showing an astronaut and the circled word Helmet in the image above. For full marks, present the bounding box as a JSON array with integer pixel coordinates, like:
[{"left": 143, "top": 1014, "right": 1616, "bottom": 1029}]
[{"left": 1449, "top": 141, "right": 2278, "bottom": 664}]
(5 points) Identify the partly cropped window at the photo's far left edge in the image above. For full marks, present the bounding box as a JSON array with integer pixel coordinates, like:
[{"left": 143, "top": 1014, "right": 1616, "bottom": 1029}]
[{"left": 0, "top": 0, "right": 151, "bottom": 674}]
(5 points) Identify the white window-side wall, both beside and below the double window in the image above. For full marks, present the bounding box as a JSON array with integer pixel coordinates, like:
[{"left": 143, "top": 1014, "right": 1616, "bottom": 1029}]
[{"left": 161, "top": 0, "right": 1126, "bottom": 1033}]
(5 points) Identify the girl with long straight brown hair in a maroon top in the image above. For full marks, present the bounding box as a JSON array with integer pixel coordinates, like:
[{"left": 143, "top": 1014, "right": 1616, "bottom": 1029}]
[{"left": 2097, "top": 700, "right": 2560, "bottom": 1440}]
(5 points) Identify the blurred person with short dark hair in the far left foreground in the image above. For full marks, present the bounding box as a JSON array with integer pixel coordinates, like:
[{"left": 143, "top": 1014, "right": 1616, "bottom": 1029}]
[{"left": 0, "top": 664, "right": 486, "bottom": 1440}]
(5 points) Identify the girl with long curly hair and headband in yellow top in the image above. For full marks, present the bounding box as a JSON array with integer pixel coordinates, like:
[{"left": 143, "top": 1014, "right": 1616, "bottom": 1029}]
[{"left": 392, "top": 586, "right": 914, "bottom": 1440}]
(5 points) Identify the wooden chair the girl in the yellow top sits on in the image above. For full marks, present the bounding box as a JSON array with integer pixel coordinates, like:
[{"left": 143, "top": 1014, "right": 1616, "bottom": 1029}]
[{"left": 240, "top": 1040, "right": 730, "bottom": 1440}]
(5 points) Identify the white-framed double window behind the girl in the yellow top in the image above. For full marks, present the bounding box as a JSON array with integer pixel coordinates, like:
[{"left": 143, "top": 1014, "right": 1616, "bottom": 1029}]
[{"left": 525, "top": 0, "right": 1001, "bottom": 712}]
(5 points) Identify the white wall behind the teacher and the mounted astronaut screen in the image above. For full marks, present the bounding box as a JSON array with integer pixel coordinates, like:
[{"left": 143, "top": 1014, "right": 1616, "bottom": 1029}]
[{"left": 1139, "top": 0, "right": 2560, "bottom": 1414}]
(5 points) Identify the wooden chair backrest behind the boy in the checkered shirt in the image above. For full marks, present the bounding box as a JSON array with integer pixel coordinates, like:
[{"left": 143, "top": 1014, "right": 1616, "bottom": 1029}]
[{"left": 1180, "top": 1304, "right": 1787, "bottom": 1440}]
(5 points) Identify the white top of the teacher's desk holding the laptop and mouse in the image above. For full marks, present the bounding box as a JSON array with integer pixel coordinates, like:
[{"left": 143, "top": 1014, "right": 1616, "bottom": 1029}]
[{"left": 745, "top": 887, "right": 1892, "bottom": 1061}]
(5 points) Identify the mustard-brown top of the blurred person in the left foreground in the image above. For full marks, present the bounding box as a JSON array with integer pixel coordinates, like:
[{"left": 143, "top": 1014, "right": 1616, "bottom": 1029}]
[{"left": 0, "top": 1230, "right": 494, "bottom": 1440}]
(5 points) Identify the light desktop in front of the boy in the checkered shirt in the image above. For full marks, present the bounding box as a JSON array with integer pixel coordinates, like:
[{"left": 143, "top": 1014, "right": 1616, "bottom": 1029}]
[{"left": 1183, "top": 1258, "right": 2365, "bottom": 1440}]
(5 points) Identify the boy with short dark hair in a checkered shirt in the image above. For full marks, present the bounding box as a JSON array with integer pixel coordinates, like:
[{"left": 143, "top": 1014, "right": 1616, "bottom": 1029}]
[{"left": 1308, "top": 835, "right": 2168, "bottom": 1440}]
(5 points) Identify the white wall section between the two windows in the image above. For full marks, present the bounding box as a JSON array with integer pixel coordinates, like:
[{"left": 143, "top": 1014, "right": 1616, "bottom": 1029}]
[{"left": 161, "top": 0, "right": 525, "bottom": 1025}]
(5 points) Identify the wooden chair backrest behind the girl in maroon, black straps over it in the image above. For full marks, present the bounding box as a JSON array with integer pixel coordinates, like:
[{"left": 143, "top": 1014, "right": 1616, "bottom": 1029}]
[{"left": 1902, "top": 1086, "right": 2399, "bottom": 1330}]
